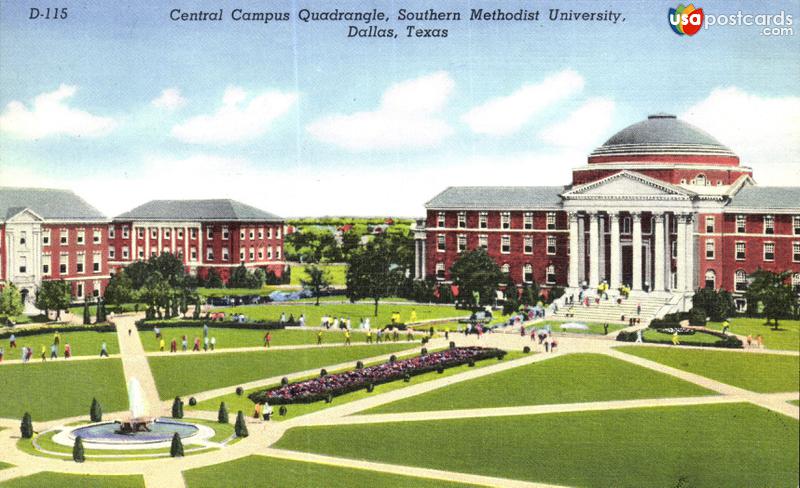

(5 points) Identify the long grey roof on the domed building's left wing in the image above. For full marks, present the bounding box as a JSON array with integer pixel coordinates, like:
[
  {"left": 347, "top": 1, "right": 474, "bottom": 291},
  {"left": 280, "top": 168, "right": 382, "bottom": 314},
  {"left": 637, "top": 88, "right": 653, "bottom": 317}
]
[{"left": 425, "top": 186, "right": 564, "bottom": 210}]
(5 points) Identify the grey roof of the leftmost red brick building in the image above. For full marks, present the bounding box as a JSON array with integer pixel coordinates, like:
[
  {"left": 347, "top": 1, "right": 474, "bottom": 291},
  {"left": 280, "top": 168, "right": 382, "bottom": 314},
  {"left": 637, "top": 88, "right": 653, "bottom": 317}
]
[{"left": 0, "top": 187, "right": 108, "bottom": 222}]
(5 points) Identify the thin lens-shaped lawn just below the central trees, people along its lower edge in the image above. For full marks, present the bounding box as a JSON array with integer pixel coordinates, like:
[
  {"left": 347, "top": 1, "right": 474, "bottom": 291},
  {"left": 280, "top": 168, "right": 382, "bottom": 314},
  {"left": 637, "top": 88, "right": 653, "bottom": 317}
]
[{"left": 215, "top": 303, "right": 469, "bottom": 329}]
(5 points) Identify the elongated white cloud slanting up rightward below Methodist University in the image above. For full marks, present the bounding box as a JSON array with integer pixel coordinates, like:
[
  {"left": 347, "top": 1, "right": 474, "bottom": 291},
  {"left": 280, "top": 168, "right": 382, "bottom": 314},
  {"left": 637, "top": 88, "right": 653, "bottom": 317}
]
[{"left": 462, "top": 70, "right": 584, "bottom": 136}]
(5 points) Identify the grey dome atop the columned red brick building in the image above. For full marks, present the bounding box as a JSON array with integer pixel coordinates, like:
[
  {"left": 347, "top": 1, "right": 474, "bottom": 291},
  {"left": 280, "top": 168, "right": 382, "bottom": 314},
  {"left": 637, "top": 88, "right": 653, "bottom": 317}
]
[{"left": 590, "top": 114, "right": 736, "bottom": 162}]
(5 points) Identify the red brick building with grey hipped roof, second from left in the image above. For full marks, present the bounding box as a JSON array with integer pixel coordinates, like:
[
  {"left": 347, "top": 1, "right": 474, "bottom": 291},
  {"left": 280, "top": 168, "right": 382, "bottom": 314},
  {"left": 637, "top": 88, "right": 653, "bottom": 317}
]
[{"left": 108, "top": 200, "right": 286, "bottom": 281}]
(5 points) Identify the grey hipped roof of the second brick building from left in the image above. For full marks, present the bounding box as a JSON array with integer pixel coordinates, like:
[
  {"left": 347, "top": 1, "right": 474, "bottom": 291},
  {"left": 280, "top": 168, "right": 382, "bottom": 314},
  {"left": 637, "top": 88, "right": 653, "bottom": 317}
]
[{"left": 114, "top": 199, "right": 283, "bottom": 222}]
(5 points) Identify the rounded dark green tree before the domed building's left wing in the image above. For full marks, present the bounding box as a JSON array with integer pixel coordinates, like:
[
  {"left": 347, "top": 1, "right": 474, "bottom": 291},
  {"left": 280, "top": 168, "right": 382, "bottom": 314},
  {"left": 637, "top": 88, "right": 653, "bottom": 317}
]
[{"left": 450, "top": 249, "right": 503, "bottom": 305}]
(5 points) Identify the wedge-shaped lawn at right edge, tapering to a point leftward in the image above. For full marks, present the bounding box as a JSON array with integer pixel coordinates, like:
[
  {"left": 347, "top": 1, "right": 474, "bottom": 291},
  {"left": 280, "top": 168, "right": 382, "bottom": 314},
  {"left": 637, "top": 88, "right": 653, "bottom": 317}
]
[{"left": 617, "top": 346, "right": 800, "bottom": 393}]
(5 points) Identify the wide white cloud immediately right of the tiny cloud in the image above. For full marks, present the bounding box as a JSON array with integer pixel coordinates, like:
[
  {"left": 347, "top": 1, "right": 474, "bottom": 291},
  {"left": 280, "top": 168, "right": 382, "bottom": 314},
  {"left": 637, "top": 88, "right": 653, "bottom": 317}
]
[{"left": 172, "top": 87, "right": 298, "bottom": 144}]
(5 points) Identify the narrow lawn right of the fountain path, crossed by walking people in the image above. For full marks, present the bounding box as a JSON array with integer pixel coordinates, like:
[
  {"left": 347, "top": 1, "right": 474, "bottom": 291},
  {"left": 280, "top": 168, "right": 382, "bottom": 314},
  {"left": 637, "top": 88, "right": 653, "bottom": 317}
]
[{"left": 139, "top": 322, "right": 396, "bottom": 351}]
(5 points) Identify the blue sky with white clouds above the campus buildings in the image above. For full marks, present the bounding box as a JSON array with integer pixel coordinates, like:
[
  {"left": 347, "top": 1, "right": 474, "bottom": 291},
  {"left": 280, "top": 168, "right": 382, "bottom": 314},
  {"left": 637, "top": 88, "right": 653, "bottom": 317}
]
[{"left": 0, "top": 0, "right": 800, "bottom": 217}]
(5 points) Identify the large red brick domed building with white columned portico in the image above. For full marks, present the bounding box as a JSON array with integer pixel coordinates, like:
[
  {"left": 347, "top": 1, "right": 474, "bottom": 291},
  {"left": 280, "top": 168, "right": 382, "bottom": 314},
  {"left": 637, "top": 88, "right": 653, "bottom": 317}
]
[{"left": 415, "top": 114, "right": 800, "bottom": 309}]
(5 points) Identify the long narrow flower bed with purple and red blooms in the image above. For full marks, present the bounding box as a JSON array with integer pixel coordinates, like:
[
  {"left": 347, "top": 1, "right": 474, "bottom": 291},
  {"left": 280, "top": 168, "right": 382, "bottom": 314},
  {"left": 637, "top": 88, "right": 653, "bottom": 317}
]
[{"left": 248, "top": 347, "right": 506, "bottom": 405}]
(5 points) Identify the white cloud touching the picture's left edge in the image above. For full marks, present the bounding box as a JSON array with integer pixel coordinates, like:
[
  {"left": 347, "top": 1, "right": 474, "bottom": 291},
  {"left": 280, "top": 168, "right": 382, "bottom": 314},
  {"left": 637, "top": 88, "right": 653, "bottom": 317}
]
[{"left": 0, "top": 85, "right": 117, "bottom": 139}]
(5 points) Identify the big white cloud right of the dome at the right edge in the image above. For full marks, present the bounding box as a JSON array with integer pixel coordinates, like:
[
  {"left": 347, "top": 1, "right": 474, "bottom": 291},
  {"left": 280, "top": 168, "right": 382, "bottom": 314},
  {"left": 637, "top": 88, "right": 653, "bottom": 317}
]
[{"left": 683, "top": 87, "right": 800, "bottom": 185}]
